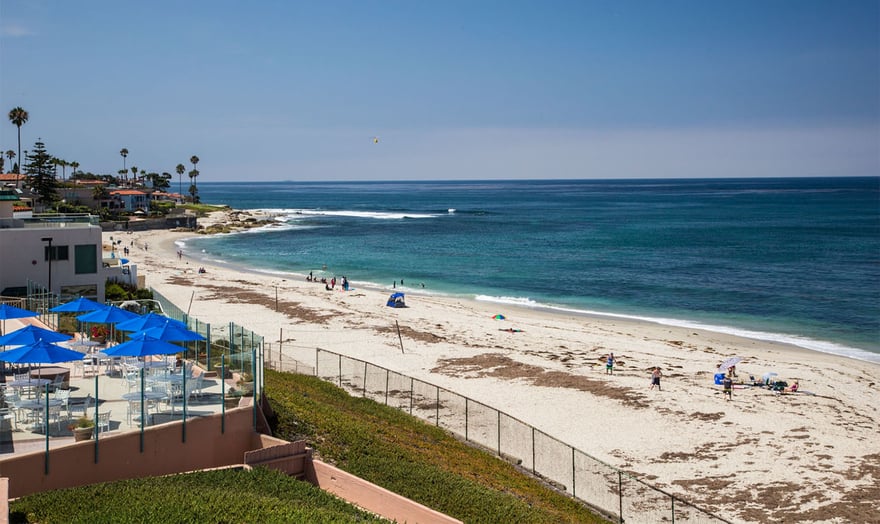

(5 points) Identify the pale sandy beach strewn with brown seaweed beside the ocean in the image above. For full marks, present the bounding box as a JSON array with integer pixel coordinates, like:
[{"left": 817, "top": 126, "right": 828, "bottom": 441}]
[{"left": 111, "top": 212, "right": 880, "bottom": 522}]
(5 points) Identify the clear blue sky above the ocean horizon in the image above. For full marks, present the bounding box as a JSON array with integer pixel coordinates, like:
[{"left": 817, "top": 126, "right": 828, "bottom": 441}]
[{"left": 0, "top": 0, "right": 880, "bottom": 182}]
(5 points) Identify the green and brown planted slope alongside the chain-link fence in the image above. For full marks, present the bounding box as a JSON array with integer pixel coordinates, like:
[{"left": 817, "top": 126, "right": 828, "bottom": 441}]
[{"left": 266, "top": 370, "right": 606, "bottom": 524}]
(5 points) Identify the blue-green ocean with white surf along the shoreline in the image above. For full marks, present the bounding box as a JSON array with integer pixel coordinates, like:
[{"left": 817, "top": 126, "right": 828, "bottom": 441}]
[{"left": 180, "top": 177, "right": 880, "bottom": 362}]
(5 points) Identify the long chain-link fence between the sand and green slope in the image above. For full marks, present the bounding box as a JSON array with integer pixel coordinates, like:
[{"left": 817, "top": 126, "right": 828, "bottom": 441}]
[{"left": 263, "top": 343, "right": 730, "bottom": 524}]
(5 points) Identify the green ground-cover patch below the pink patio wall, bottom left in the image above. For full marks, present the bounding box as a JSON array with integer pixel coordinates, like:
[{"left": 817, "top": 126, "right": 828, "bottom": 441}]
[{"left": 9, "top": 468, "right": 387, "bottom": 523}]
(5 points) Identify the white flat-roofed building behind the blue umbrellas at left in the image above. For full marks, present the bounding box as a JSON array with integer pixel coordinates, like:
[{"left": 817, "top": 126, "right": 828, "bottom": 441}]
[{"left": 0, "top": 191, "right": 137, "bottom": 302}]
